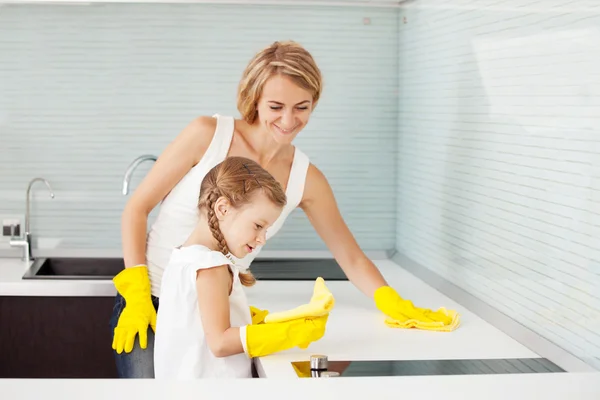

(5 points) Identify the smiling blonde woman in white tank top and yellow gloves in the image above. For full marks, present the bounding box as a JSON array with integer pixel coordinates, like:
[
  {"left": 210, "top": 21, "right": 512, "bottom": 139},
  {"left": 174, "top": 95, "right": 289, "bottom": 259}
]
[{"left": 111, "top": 42, "right": 450, "bottom": 378}]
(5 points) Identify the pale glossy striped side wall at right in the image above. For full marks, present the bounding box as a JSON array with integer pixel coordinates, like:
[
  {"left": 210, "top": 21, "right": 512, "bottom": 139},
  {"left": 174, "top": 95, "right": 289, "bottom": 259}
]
[{"left": 396, "top": 0, "right": 600, "bottom": 367}]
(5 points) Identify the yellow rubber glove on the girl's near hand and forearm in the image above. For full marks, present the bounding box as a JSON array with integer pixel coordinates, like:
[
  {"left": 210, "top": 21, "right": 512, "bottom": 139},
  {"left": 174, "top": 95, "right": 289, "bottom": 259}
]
[{"left": 246, "top": 314, "right": 329, "bottom": 358}]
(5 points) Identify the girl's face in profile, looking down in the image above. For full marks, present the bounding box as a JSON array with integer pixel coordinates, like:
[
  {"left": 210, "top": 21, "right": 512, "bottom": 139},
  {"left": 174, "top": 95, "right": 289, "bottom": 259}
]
[{"left": 215, "top": 190, "right": 283, "bottom": 258}]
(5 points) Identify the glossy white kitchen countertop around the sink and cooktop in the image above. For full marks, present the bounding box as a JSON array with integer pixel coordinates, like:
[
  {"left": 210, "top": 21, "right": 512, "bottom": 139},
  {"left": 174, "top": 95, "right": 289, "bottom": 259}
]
[{"left": 0, "top": 258, "right": 600, "bottom": 399}]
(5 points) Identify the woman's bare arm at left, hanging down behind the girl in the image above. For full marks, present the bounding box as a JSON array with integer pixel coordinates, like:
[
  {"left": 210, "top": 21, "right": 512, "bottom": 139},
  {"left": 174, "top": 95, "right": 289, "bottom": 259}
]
[{"left": 121, "top": 117, "right": 216, "bottom": 268}]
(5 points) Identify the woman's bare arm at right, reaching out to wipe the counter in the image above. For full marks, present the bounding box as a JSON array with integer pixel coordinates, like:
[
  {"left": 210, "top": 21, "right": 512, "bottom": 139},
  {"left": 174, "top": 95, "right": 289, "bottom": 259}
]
[{"left": 300, "top": 164, "right": 387, "bottom": 298}]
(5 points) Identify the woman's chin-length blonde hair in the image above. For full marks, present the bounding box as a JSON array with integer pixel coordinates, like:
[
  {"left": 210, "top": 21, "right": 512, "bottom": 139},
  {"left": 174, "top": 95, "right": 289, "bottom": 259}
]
[{"left": 237, "top": 41, "right": 323, "bottom": 124}]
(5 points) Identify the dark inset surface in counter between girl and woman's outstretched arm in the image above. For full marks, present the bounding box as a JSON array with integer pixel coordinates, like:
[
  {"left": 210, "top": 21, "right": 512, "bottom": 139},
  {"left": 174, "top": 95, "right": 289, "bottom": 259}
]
[{"left": 250, "top": 258, "right": 348, "bottom": 281}]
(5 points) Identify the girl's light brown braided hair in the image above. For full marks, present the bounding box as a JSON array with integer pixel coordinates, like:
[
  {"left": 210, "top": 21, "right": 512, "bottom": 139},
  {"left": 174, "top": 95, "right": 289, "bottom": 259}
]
[{"left": 198, "top": 157, "right": 287, "bottom": 286}]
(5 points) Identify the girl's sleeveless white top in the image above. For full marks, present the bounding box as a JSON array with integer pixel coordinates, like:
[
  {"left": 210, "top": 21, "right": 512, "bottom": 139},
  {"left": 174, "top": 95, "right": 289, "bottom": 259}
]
[{"left": 154, "top": 245, "right": 252, "bottom": 379}]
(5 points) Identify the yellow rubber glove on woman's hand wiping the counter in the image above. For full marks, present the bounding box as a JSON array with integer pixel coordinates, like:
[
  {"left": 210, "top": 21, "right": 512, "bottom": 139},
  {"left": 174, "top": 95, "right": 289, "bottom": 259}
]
[{"left": 374, "top": 286, "right": 452, "bottom": 325}]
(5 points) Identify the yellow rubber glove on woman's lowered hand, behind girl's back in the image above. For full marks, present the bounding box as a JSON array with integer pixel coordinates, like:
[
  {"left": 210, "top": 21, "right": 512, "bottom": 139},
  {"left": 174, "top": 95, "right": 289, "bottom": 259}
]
[{"left": 112, "top": 265, "right": 156, "bottom": 354}]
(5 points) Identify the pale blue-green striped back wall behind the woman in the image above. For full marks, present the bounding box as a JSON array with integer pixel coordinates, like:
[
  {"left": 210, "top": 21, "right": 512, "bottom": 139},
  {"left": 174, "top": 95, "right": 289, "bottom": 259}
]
[{"left": 0, "top": 4, "right": 398, "bottom": 250}]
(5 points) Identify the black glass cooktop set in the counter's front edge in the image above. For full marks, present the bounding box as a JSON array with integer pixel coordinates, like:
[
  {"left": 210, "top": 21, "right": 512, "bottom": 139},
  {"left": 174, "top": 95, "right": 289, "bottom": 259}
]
[{"left": 292, "top": 358, "right": 566, "bottom": 378}]
